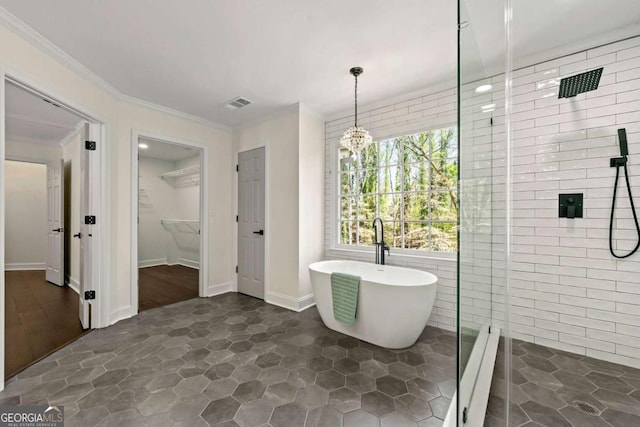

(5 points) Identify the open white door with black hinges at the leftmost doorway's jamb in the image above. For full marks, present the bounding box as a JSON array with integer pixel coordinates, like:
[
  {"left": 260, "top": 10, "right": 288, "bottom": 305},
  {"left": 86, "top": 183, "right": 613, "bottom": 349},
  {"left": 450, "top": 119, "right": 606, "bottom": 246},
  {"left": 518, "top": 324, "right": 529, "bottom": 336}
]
[{"left": 74, "top": 123, "right": 97, "bottom": 329}]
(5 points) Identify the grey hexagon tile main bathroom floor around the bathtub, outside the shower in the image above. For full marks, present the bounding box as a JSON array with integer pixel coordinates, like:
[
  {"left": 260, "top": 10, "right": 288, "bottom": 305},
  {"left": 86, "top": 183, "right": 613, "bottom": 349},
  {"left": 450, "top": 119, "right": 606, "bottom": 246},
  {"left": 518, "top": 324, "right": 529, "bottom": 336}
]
[{"left": 0, "top": 294, "right": 456, "bottom": 427}]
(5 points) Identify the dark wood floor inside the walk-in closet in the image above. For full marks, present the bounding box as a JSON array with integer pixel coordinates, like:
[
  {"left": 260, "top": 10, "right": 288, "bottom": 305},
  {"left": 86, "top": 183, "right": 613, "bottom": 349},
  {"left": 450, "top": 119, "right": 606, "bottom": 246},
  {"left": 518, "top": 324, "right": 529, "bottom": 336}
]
[{"left": 138, "top": 265, "right": 200, "bottom": 311}]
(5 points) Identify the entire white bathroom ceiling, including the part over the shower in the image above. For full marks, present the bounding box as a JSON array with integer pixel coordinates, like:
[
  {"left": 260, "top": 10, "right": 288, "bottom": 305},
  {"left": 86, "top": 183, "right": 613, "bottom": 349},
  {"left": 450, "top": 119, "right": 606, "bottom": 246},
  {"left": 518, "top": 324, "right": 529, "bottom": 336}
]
[{"left": 0, "top": 0, "right": 640, "bottom": 126}]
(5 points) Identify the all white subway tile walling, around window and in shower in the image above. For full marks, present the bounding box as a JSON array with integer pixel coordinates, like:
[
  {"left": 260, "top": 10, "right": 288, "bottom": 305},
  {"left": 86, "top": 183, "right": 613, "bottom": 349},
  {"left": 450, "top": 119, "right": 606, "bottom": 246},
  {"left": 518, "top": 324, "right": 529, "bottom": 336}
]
[{"left": 325, "top": 37, "right": 640, "bottom": 368}]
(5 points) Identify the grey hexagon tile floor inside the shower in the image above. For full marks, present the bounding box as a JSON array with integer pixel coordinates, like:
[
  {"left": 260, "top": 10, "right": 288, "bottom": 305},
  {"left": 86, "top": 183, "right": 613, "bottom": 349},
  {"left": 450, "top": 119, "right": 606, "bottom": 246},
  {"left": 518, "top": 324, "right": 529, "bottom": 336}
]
[{"left": 485, "top": 340, "right": 640, "bottom": 427}]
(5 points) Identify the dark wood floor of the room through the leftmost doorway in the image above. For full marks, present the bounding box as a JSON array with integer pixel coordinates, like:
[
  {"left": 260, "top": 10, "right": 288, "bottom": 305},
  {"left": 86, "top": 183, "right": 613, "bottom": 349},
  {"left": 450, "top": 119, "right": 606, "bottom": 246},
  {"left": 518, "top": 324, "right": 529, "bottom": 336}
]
[{"left": 4, "top": 271, "right": 86, "bottom": 378}]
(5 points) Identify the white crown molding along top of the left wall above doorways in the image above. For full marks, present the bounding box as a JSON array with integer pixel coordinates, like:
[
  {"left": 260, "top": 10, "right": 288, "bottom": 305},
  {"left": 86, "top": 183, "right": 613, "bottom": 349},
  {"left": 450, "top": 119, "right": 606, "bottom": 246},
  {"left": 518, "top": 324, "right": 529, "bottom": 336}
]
[{"left": 0, "top": 7, "right": 231, "bottom": 132}]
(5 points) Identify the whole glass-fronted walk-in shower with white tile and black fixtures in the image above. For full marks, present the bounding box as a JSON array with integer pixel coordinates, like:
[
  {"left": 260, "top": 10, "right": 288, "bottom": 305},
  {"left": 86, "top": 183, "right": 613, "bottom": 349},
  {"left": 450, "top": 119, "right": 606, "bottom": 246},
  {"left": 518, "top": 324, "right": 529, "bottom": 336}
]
[{"left": 452, "top": 0, "right": 640, "bottom": 427}]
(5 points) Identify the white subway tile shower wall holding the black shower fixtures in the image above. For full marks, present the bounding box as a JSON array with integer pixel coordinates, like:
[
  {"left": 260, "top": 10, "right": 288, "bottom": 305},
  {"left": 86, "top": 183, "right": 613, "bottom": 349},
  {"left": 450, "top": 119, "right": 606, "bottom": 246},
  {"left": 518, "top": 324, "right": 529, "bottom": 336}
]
[{"left": 496, "top": 37, "right": 640, "bottom": 368}]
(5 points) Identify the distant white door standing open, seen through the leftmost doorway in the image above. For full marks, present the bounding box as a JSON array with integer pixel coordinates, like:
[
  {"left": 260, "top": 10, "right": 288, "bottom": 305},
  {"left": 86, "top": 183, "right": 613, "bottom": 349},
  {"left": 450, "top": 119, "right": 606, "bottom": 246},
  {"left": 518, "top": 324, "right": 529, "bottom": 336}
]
[{"left": 45, "top": 159, "right": 64, "bottom": 286}]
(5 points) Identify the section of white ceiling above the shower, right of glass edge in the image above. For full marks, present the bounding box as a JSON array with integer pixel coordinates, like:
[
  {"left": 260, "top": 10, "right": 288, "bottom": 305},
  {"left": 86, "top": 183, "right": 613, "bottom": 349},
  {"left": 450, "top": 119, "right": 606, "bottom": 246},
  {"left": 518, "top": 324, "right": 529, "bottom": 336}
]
[{"left": 461, "top": 0, "right": 640, "bottom": 75}]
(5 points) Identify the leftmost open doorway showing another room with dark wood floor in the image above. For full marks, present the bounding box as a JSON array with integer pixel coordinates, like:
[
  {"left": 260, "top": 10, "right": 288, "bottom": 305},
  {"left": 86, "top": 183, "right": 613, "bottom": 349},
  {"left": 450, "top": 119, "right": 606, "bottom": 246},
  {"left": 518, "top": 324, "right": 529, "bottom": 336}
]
[{"left": 3, "top": 82, "right": 88, "bottom": 378}]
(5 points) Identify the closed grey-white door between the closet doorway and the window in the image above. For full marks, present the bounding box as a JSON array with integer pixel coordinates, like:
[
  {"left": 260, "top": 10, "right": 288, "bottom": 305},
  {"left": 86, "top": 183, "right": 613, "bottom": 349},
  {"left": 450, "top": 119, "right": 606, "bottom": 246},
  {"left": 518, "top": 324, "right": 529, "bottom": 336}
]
[{"left": 238, "top": 147, "right": 265, "bottom": 299}]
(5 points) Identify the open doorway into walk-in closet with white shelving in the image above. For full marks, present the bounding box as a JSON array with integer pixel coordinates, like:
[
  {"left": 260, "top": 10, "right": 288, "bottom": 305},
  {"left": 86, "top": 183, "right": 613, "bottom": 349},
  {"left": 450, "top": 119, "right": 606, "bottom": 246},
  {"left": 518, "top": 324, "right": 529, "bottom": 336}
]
[{"left": 136, "top": 136, "right": 203, "bottom": 311}]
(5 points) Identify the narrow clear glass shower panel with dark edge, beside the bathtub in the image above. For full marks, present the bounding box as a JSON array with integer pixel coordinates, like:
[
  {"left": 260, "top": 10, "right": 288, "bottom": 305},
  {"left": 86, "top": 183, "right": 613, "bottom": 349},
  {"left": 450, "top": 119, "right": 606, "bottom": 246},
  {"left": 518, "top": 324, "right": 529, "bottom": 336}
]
[{"left": 457, "top": 0, "right": 504, "bottom": 426}]
